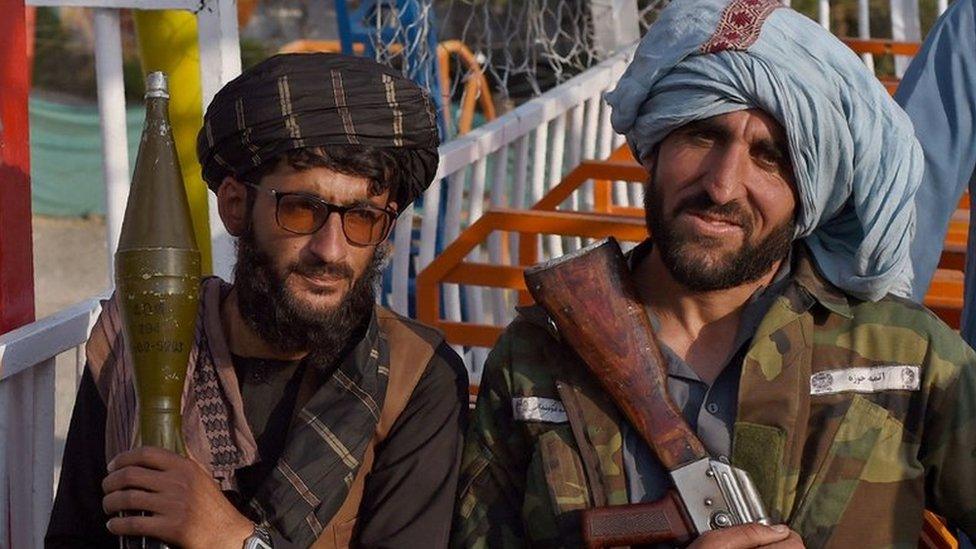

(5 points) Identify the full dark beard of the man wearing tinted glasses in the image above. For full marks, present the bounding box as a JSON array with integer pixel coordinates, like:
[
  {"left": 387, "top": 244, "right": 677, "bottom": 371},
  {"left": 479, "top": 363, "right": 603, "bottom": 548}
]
[{"left": 234, "top": 228, "right": 387, "bottom": 367}]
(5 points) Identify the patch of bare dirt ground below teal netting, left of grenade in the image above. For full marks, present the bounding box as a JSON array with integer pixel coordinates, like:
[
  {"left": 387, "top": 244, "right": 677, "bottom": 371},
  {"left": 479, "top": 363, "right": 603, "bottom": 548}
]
[{"left": 33, "top": 216, "right": 109, "bottom": 319}]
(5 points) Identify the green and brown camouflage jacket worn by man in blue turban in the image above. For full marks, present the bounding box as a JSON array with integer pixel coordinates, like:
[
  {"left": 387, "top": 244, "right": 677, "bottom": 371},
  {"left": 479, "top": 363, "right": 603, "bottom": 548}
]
[{"left": 452, "top": 248, "right": 976, "bottom": 547}]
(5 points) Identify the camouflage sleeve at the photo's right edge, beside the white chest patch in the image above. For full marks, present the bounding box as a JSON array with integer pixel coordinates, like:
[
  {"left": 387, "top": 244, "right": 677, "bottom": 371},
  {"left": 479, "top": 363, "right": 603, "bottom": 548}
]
[{"left": 919, "top": 318, "right": 976, "bottom": 537}]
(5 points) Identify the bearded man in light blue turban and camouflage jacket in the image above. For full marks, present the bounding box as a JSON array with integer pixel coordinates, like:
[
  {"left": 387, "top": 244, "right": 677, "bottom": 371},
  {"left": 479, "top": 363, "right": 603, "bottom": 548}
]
[{"left": 453, "top": 0, "right": 976, "bottom": 547}]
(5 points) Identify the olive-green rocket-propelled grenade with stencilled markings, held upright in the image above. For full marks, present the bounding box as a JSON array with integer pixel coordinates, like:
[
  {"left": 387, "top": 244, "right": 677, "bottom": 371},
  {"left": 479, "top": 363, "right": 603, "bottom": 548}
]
[{"left": 115, "top": 72, "right": 200, "bottom": 547}]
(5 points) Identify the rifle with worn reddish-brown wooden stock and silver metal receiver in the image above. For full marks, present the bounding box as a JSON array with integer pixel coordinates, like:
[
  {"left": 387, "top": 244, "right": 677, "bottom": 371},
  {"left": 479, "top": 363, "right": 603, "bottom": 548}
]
[{"left": 525, "top": 238, "right": 769, "bottom": 547}]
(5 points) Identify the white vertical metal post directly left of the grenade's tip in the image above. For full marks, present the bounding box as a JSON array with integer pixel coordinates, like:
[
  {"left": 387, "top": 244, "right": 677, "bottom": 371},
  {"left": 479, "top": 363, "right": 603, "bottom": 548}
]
[{"left": 94, "top": 8, "right": 130, "bottom": 278}]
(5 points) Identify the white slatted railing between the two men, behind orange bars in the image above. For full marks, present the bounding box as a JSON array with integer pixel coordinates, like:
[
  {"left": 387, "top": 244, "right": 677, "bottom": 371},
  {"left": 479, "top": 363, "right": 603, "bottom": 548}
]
[{"left": 387, "top": 47, "right": 639, "bottom": 380}]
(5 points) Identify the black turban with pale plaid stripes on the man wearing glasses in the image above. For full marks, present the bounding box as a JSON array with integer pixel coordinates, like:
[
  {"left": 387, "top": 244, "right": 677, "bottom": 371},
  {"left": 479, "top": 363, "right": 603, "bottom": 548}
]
[{"left": 197, "top": 53, "right": 439, "bottom": 211}]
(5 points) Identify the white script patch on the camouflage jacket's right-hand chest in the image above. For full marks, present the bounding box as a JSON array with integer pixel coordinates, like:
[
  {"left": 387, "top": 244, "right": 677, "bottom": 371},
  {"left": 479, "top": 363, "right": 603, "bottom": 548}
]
[{"left": 810, "top": 364, "right": 921, "bottom": 395}]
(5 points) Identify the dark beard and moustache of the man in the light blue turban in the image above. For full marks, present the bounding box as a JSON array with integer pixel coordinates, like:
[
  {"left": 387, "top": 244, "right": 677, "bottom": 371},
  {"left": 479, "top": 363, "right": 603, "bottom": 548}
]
[{"left": 644, "top": 181, "right": 795, "bottom": 292}]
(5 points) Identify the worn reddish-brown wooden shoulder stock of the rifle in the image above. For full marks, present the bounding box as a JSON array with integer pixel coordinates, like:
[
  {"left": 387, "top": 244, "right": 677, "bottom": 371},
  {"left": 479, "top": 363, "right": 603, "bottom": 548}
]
[{"left": 525, "top": 238, "right": 708, "bottom": 471}]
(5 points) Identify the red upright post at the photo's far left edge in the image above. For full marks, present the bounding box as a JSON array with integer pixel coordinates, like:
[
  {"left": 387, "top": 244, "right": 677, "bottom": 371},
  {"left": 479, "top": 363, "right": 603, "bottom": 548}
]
[{"left": 0, "top": 0, "right": 34, "bottom": 334}]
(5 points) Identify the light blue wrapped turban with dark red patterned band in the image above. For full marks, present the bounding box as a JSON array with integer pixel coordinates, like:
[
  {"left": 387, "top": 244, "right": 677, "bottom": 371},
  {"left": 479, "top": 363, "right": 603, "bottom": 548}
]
[{"left": 607, "top": 0, "right": 923, "bottom": 301}]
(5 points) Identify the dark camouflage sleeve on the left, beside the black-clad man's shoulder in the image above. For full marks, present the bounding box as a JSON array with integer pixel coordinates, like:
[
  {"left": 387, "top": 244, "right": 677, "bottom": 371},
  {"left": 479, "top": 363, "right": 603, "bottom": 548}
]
[{"left": 451, "top": 321, "right": 529, "bottom": 548}]
